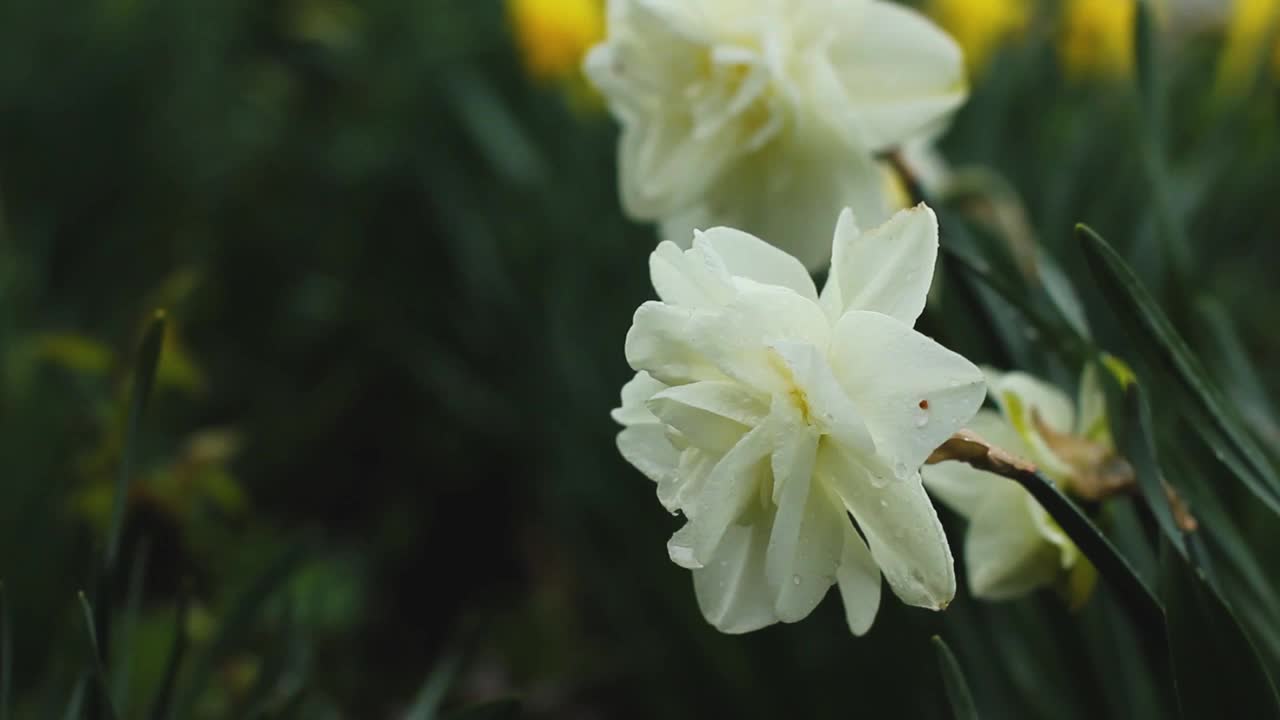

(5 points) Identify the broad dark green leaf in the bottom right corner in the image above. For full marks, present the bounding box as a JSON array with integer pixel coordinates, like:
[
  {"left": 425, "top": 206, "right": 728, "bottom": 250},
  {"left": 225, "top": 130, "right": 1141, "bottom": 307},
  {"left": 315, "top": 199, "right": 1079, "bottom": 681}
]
[{"left": 1161, "top": 538, "right": 1280, "bottom": 720}]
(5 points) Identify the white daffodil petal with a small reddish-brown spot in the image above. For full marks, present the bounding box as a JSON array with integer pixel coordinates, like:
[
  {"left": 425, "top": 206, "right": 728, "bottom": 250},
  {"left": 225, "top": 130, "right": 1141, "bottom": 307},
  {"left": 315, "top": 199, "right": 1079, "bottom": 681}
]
[{"left": 831, "top": 310, "right": 987, "bottom": 474}]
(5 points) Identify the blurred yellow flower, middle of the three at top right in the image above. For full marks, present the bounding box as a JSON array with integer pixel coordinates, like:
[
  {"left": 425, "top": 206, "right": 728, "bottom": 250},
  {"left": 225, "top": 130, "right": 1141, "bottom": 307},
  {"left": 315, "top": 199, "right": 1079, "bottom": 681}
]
[{"left": 1059, "top": 0, "right": 1137, "bottom": 79}]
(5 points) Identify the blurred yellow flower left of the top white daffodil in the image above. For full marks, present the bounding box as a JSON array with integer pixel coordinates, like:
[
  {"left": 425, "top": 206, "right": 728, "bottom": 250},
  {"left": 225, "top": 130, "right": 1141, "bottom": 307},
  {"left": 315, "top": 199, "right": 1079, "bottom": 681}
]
[{"left": 507, "top": 0, "right": 604, "bottom": 81}]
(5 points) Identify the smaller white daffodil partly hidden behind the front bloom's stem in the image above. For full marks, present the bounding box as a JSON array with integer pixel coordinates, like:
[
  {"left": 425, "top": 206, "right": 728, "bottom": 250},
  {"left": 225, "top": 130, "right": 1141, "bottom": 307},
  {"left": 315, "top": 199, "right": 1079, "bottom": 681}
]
[{"left": 922, "top": 366, "right": 1114, "bottom": 603}]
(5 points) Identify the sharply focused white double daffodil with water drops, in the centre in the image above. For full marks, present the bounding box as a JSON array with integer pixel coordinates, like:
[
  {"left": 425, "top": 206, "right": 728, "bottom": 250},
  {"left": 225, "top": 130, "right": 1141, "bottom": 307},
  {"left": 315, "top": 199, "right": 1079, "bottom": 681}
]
[{"left": 613, "top": 205, "right": 984, "bottom": 634}]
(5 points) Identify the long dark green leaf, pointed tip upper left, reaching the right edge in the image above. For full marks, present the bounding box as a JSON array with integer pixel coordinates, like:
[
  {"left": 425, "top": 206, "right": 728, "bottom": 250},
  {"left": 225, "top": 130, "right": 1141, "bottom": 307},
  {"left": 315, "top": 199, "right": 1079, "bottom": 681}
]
[{"left": 1076, "top": 225, "right": 1280, "bottom": 512}]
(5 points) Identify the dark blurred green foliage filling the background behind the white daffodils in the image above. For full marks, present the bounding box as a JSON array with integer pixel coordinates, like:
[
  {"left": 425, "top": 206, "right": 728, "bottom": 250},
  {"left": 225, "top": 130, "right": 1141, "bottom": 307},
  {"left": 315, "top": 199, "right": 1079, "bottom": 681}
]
[{"left": 0, "top": 0, "right": 1280, "bottom": 719}]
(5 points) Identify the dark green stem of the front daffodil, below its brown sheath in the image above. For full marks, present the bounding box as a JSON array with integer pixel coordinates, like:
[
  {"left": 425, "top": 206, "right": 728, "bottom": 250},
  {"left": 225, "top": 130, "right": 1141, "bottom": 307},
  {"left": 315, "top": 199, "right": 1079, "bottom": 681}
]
[{"left": 1016, "top": 473, "right": 1165, "bottom": 647}]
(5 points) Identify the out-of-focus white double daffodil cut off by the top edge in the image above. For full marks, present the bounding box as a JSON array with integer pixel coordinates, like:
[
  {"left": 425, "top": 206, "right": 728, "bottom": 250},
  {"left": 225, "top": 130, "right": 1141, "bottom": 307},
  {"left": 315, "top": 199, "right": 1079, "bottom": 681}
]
[{"left": 585, "top": 0, "right": 966, "bottom": 268}]
